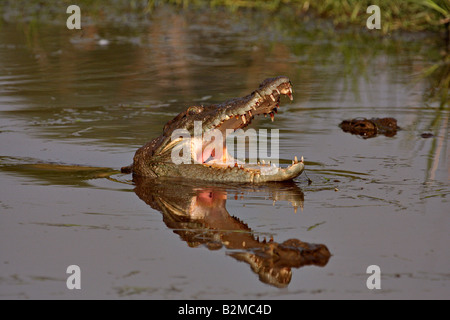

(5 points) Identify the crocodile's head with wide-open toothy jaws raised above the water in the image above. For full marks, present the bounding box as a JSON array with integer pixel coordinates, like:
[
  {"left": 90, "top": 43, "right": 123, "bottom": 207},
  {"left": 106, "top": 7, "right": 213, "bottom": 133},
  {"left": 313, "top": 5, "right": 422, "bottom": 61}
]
[{"left": 121, "top": 76, "right": 304, "bottom": 183}]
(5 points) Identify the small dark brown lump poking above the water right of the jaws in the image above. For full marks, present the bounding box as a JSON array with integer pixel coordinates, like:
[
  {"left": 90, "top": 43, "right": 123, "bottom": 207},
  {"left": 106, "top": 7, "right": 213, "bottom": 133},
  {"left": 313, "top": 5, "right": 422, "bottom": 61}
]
[{"left": 339, "top": 118, "right": 400, "bottom": 139}]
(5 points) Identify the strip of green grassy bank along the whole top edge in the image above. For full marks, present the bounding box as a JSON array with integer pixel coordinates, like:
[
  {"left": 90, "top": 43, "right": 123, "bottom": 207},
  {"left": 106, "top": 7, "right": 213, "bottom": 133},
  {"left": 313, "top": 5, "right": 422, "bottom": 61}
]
[{"left": 0, "top": 0, "right": 450, "bottom": 34}]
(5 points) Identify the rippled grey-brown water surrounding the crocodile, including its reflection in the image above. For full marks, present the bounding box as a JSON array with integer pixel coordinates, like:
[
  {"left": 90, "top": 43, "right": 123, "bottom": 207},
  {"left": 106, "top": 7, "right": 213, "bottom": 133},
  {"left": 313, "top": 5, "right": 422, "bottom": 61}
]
[{"left": 0, "top": 3, "right": 450, "bottom": 299}]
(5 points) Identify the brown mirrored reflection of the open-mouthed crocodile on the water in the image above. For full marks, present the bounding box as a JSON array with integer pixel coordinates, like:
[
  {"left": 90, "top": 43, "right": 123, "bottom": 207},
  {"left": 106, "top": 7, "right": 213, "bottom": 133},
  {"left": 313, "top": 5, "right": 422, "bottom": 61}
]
[{"left": 133, "top": 176, "right": 331, "bottom": 288}]
